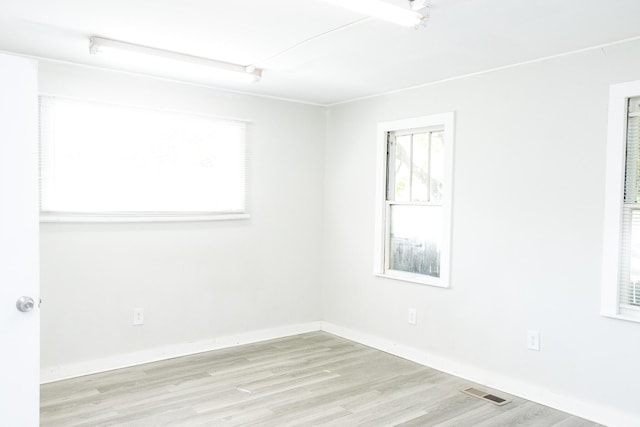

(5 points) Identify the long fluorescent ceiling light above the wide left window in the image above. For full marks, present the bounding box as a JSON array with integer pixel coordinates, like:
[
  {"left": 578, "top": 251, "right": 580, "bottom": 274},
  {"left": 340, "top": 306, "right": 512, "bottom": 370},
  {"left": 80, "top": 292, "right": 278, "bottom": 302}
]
[{"left": 89, "top": 36, "right": 262, "bottom": 83}]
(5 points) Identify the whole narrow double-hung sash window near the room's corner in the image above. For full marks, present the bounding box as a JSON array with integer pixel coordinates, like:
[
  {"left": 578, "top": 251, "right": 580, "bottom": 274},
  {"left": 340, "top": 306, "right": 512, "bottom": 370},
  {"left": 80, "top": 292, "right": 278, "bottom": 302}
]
[{"left": 375, "top": 113, "right": 454, "bottom": 287}]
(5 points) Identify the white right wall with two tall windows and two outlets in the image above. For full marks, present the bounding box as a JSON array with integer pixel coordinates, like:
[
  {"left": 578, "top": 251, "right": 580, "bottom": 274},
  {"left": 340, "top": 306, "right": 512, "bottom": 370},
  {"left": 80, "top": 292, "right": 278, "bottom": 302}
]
[{"left": 322, "top": 41, "right": 640, "bottom": 425}]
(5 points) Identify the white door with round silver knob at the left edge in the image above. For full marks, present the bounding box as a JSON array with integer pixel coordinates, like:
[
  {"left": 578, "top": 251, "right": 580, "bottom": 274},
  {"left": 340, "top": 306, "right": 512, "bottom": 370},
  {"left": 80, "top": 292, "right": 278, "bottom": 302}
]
[{"left": 0, "top": 54, "right": 40, "bottom": 427}]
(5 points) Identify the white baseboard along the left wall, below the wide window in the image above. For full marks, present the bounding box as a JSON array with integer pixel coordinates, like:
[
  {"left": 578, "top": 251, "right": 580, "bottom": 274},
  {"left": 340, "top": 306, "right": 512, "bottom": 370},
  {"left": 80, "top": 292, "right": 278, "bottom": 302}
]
[{"left": 40, "top": 322, "right": 320, "bottom": 384}]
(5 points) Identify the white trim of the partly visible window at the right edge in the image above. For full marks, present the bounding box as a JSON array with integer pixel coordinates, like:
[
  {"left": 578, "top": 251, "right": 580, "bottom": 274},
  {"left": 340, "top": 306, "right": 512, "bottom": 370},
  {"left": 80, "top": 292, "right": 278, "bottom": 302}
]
[{"left": 600, "top": 81, "right": 640, "bottom": 322}]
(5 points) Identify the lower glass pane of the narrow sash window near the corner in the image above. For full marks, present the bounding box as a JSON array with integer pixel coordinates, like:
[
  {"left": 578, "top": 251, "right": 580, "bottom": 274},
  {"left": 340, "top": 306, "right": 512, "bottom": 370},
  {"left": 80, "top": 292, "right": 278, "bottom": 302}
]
[{"left": 389, "top": 205, "right": 442, "bottom": 277}]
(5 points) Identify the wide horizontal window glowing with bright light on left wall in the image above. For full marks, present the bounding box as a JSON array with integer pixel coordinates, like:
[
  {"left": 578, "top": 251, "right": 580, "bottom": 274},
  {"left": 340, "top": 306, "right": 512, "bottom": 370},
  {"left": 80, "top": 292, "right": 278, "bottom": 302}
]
[{"left": 40, "top": 97, "right": 247, "bottom": 221}]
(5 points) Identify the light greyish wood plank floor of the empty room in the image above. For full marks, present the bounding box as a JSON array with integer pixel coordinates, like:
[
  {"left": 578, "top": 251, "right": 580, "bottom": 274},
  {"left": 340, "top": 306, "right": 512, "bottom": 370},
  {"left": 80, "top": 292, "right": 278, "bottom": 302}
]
[{"left": 40, "top": 332, "right": 597, "bottom": 427}]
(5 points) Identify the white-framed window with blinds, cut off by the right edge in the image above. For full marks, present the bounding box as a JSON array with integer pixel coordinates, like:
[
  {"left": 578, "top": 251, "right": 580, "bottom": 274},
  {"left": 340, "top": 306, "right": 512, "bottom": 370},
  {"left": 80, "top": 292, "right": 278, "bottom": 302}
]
[{"left": 602, "top": 82, "right": 640, "bottom": 321}]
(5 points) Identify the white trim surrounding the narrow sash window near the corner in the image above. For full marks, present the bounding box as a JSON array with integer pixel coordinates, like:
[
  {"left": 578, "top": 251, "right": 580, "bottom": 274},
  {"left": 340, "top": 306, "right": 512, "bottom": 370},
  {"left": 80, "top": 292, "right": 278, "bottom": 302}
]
[{"left": 374, "top": 112, "right": 455, "bottom": 288}]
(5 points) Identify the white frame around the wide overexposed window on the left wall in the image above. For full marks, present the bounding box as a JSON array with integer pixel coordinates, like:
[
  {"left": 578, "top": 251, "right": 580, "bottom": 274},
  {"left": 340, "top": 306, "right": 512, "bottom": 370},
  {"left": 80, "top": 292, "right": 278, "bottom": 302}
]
[{"left": 39, "top": 94, "right": 250, "bottom": 223}]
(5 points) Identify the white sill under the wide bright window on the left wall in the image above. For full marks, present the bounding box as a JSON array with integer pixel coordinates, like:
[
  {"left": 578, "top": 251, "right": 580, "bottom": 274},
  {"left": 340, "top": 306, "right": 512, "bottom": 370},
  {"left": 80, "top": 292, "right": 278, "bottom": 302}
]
[{"left": 40, "top": 213, "right": 250, "bottom": 223}]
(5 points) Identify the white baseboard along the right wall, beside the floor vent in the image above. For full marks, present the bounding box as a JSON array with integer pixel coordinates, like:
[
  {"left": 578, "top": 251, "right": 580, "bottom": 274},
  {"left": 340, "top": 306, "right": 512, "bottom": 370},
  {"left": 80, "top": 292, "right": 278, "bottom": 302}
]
[{"left": 321, "top": 322, "right": 640, "bottom": 427}]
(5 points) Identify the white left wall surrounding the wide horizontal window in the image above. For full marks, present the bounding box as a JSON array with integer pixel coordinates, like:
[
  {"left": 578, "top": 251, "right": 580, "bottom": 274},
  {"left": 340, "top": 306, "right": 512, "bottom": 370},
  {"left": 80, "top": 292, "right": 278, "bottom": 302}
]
[{"left": 40, "top": 62, "right": 325, "bottom": 379}]
